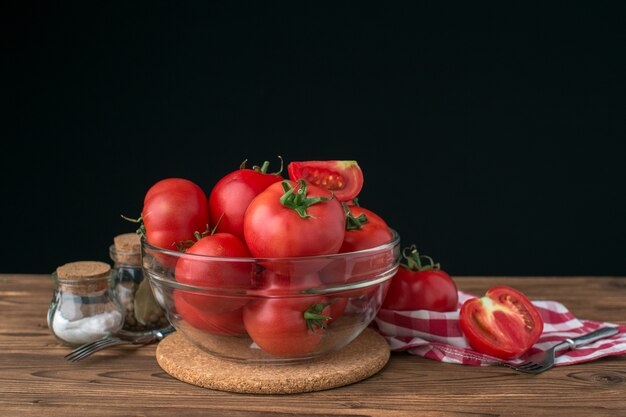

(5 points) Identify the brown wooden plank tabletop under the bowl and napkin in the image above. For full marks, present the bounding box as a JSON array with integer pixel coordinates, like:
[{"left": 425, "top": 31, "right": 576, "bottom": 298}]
[{"left": 0, "top": 275, "right": 626, "bottom": 417}]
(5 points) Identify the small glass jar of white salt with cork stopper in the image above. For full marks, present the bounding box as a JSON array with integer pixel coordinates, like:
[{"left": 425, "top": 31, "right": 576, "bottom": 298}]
[{"left": 48, "top": 261, "right": 124, "bottom": 346}]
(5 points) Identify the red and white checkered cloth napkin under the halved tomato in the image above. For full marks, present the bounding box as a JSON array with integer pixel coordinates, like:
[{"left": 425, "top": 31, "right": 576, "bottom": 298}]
[{"left": 372, "top": 291, "right": 626, "bottom": 366}]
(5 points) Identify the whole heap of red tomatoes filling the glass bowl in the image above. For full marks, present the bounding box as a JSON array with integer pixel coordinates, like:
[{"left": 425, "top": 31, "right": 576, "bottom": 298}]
[{"left": 136, "top": 161, "right": 393, "bottom": 356}]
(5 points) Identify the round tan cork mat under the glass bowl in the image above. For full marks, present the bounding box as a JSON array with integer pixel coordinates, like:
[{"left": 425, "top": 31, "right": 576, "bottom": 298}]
[{"left": 156, "top": 329, "right": 390, "bottom": 394}]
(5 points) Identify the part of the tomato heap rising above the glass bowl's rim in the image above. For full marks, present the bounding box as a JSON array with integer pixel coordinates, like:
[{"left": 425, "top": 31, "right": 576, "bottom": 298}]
[{"left": 141, "top": 161, "right": 392, "bottom": 258}]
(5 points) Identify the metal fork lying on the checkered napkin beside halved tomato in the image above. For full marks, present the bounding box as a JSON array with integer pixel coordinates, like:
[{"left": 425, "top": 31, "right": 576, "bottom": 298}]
[{"left": 502, "top": 327, "right": 619, "bottom": 374}]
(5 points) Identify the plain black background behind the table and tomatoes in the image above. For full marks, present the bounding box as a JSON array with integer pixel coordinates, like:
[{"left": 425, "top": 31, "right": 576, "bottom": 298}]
[{"left": 0, "top": 2, "right": 626, "bottom": 275}]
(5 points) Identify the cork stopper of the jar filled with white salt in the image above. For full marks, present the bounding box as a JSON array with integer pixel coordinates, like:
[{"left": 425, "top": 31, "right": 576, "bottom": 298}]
[{"left": 56, "top": 261, "right": 111, "bottom": 295}]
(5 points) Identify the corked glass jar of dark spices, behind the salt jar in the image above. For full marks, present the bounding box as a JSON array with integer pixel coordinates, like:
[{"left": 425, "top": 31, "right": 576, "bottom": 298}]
[{"left": 109, "top": 233, "right": 168, "bottom": 334}]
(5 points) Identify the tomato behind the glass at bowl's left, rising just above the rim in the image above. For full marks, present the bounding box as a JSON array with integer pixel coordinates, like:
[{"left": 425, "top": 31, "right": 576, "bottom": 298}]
[{"left": 175, "top": 233, "right": 254, "bottom": 313}]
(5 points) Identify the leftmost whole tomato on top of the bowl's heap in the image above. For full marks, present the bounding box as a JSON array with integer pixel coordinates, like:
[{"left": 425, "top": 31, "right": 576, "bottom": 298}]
[{"left": 141, "top": 178, "right": 209, "bottom": 250}]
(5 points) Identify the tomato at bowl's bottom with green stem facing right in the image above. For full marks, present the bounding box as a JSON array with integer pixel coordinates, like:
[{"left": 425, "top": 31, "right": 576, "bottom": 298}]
[{"left": 243, "top": 296, "right": 329, "bottom": 357}]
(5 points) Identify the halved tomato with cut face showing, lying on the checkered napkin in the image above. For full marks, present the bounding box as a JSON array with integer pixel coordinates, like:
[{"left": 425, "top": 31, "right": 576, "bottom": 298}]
[{"left": 459, "top": 286, "right": 543, "bottom": 359}]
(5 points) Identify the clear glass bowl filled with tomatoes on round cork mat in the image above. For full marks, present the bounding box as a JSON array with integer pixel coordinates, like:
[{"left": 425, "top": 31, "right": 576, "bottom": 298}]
[{"left": 142, "top": 230, "right": 400, "bottom": 364}]
